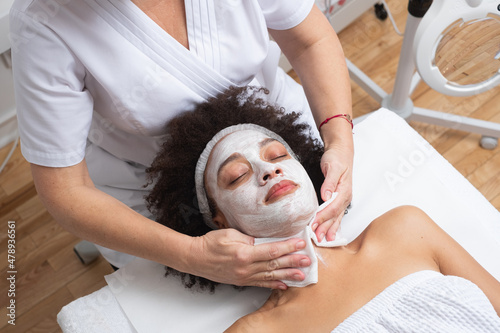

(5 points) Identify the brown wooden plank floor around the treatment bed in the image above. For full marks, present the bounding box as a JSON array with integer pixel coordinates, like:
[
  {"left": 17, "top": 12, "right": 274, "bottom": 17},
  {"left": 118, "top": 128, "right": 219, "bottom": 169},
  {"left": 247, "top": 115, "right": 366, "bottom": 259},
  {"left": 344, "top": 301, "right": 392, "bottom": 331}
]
[{"left": 0, "top": 0, "right": 500, "bottom": 332}]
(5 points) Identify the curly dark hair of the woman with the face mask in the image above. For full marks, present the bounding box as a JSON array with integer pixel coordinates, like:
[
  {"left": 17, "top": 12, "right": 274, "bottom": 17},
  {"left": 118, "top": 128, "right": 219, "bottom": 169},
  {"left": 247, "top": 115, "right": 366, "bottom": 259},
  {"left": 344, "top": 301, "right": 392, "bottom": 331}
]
[{"left": 146, "top": 87, "right": 324, "bottom": 292}]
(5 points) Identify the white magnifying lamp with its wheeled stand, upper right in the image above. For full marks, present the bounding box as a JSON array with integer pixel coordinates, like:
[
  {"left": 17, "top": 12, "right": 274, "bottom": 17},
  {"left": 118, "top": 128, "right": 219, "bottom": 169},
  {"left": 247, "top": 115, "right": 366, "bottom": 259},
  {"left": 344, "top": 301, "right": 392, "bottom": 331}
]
[{"left": 346, "top": 0, "right": 500, "bottom": 149}]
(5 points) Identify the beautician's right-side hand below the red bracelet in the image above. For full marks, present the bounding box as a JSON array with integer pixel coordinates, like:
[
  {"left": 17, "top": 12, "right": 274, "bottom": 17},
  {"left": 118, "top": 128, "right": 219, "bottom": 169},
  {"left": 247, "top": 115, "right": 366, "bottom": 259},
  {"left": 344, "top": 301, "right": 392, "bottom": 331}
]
[{"left": 312, "top": 147, "right": 353, "bottom": 241}]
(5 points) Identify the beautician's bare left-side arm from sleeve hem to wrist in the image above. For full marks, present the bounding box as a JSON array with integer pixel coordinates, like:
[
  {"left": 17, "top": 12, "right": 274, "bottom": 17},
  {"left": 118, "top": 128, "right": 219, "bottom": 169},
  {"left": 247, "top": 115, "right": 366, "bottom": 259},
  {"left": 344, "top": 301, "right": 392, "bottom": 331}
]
[{"left": 32, "top": 162, "right": 191, "bottom": 271}]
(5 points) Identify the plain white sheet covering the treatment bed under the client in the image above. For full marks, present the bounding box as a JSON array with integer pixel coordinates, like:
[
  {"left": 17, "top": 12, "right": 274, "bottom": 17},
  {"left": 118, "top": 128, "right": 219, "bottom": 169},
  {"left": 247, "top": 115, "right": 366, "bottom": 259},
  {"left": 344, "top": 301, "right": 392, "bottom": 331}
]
[{"left": 58, "top": 109, "right": 500, "bottom": 333}]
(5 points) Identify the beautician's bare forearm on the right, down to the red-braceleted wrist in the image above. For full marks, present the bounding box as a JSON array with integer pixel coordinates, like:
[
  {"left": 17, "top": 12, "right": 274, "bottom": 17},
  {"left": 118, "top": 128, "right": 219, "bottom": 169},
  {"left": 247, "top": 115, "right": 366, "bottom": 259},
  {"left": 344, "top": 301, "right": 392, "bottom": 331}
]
[{"left": 271, "top": 8, "right": 352, "bottom": 147}]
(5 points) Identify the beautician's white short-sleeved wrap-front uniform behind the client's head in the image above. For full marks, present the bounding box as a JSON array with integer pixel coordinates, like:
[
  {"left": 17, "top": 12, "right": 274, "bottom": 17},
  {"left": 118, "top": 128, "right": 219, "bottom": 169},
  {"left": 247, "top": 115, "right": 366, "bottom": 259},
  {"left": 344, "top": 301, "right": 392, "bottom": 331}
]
[{"left": 10, "top": 0, "right": 315, "bottom": 267}]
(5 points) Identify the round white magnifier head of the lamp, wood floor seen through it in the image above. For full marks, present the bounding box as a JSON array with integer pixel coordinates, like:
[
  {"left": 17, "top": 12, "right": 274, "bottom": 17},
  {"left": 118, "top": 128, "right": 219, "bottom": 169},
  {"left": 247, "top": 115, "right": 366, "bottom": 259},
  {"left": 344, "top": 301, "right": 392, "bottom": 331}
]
[{"left": 413, "top": 0, "right": 500, "bottom": 96}]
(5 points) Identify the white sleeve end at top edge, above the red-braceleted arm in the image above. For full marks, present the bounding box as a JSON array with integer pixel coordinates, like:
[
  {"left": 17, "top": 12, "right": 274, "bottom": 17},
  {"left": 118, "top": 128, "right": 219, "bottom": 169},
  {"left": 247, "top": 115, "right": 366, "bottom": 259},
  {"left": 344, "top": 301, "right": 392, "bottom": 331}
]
[{"left": 258, "top": 0, "right": 315, "bottom": 30}]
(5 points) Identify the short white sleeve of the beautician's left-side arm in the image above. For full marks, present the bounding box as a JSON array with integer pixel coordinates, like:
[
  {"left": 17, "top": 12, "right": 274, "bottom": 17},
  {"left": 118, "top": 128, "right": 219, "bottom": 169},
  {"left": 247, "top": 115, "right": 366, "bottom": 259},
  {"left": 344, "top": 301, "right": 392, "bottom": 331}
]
[{"left": 10, "top": 9, "right": 93, "bottom": 167}]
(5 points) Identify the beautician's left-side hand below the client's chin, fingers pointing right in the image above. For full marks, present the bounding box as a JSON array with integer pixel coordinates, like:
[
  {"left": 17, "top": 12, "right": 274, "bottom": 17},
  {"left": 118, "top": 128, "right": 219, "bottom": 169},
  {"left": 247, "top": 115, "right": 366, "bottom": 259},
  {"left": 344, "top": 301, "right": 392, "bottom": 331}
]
[{"left": 188, "top": 229, "right": 311, "bottom": 289}]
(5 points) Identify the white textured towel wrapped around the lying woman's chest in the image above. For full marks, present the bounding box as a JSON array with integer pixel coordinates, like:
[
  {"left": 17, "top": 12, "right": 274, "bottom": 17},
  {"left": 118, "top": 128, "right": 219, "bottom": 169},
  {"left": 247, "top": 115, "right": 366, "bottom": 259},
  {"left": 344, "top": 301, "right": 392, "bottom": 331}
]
[{"left": 332, "top": 271, "right": 500, "bottom": 333}]
